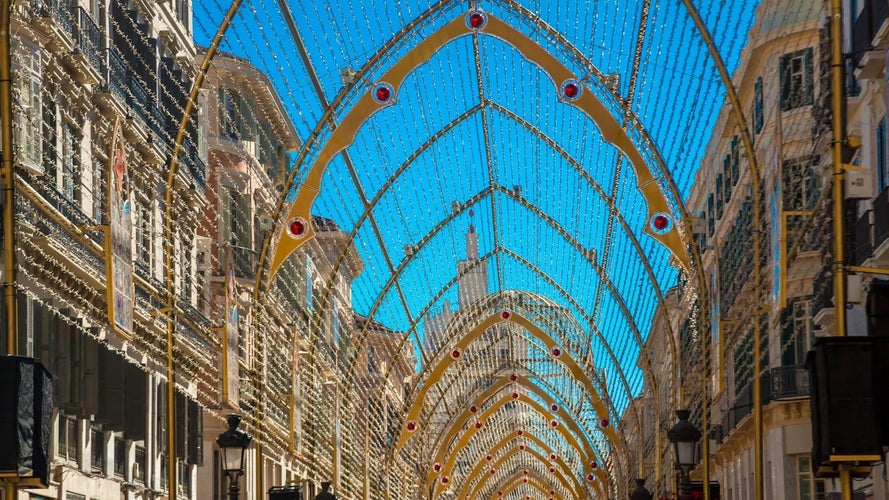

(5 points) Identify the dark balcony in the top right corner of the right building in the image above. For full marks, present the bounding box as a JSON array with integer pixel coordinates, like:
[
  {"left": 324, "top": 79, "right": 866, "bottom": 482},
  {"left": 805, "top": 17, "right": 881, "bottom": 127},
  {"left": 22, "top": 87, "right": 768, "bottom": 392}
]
[{"left": 852, "top": 0, "right": 889, "bottom": 78}]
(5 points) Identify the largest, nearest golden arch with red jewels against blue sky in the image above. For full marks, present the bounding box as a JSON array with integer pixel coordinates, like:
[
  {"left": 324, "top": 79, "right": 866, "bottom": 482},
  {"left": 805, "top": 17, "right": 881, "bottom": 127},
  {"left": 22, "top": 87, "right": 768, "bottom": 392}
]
[{"left": 269, "top": 9, "right": 690, "bottom": 280}]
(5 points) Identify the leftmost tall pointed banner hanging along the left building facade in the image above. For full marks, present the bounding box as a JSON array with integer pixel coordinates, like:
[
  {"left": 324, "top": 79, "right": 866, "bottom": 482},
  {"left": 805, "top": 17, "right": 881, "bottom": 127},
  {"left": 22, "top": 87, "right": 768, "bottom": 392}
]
[{"left": 105, "top": 120, "right": 136, "bottom": 338}]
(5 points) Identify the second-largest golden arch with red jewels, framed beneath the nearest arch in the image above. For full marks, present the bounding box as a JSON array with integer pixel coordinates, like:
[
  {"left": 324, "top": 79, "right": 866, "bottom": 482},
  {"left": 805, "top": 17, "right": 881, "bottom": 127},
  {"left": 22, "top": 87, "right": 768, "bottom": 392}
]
[{"left": 395, "top": 312, "right": 620, "bottom": 453}]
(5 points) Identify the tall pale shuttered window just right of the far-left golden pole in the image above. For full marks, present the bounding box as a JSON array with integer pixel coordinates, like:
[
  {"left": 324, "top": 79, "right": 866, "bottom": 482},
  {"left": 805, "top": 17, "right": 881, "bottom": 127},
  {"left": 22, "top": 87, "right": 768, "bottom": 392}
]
[{"left": 13, "top": 39, "right": 43, "bottom": 171}]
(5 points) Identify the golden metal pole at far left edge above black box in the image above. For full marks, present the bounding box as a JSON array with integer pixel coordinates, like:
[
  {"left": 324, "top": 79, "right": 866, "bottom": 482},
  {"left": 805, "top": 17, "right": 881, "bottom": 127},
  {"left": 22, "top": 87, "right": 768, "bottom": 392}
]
[{"left": 0, "top": 0, "right": 18, "bottom": 355}]
